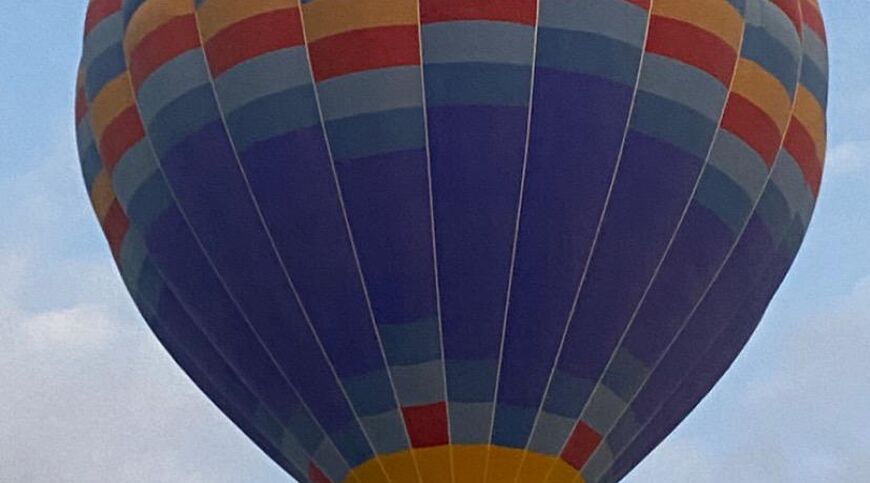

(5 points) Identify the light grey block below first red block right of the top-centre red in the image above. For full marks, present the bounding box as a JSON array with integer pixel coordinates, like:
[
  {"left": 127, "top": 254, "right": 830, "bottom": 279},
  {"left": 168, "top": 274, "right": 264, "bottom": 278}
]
[{"left": 639, "top": 55, "right": 727, "bottom": 123}]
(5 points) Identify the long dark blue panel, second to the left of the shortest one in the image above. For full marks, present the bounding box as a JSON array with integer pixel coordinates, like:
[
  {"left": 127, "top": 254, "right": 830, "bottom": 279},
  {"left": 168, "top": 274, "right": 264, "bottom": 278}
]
[{"left": 146, "top": 115, "right": 378, "bottom": 461}]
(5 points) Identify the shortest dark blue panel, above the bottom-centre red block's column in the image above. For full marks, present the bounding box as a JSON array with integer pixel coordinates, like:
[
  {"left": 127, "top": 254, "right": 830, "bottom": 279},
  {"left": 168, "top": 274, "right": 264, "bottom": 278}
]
[{"left": 336, "top": 150, "right": 435, "bottom": 324}]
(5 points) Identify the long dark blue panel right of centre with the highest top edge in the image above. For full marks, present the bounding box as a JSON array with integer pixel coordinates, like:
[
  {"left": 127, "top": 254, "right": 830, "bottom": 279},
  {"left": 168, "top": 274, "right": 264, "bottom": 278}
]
[{"left": 498, "top": 69, "right": 632, "bottom": 416}]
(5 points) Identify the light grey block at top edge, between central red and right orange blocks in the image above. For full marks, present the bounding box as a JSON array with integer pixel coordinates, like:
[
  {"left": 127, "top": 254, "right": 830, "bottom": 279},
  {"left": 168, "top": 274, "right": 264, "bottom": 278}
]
[{"left": 539, "top": 0, "right": 647, "bottom": 48}]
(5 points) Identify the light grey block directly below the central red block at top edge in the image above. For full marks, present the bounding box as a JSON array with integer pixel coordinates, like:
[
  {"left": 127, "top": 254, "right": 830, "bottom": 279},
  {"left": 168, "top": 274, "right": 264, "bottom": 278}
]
[{"left": 423, "top": 21, "right": 534, "bottom": 65}]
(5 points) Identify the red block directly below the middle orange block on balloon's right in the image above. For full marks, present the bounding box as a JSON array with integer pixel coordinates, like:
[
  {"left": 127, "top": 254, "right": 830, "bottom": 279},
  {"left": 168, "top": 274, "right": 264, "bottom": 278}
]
[{"left": 722, "top": 92, "right": 782, "bottom": 168}]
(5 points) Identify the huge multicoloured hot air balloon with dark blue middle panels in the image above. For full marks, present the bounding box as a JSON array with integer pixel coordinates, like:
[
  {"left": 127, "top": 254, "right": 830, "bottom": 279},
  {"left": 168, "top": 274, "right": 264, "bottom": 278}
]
[{"left": 76, "top": 0, "right": 827, "bottom": 483}]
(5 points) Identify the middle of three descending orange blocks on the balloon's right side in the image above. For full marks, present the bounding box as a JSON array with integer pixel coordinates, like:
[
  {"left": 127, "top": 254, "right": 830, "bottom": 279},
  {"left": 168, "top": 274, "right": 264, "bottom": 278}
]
[{"left": 732, "top": 59, "right": 792, "bottom": 133}]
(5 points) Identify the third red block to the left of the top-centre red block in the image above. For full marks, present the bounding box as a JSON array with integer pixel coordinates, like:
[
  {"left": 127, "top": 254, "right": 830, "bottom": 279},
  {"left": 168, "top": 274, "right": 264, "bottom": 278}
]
[{"left": 130, "top": 15, "right": 199, "bottom": 89}]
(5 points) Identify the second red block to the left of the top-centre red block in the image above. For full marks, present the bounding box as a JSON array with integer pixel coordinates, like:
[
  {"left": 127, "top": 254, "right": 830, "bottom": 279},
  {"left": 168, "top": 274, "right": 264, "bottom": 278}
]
[{"left": 205, "top": 8, "right": 304, "bottom": 77}]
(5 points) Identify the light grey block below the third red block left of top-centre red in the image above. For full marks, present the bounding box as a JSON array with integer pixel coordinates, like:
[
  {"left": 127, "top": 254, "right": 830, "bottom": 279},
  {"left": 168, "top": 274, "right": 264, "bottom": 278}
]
[{"left": 136, "top": 49, "right": 209, "bottom": 125}]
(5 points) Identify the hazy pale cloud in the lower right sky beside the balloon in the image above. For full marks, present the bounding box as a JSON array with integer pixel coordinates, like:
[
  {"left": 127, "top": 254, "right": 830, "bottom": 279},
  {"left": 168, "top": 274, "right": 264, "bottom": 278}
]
[{"left": 628, "top": 279, "right": 870, "bottom": 483}]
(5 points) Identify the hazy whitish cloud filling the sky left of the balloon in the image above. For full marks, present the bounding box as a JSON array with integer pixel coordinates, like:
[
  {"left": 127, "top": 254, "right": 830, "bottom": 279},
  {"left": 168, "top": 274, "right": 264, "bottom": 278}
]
[{"left": 0, "top": 126, "right": 287, "bottom": 483}]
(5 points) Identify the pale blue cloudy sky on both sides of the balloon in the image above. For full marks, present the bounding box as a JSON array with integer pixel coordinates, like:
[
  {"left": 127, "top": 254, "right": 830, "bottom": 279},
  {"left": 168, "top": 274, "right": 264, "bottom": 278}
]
[{"left": 0, "top": 0, "right": 870, "bottom": 483}]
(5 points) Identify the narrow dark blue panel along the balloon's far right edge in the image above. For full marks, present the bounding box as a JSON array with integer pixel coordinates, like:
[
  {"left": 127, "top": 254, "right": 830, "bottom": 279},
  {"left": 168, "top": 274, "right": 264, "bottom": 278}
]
[{"left": 604, "top": 212, "right": 804, "bottom": 481}]
